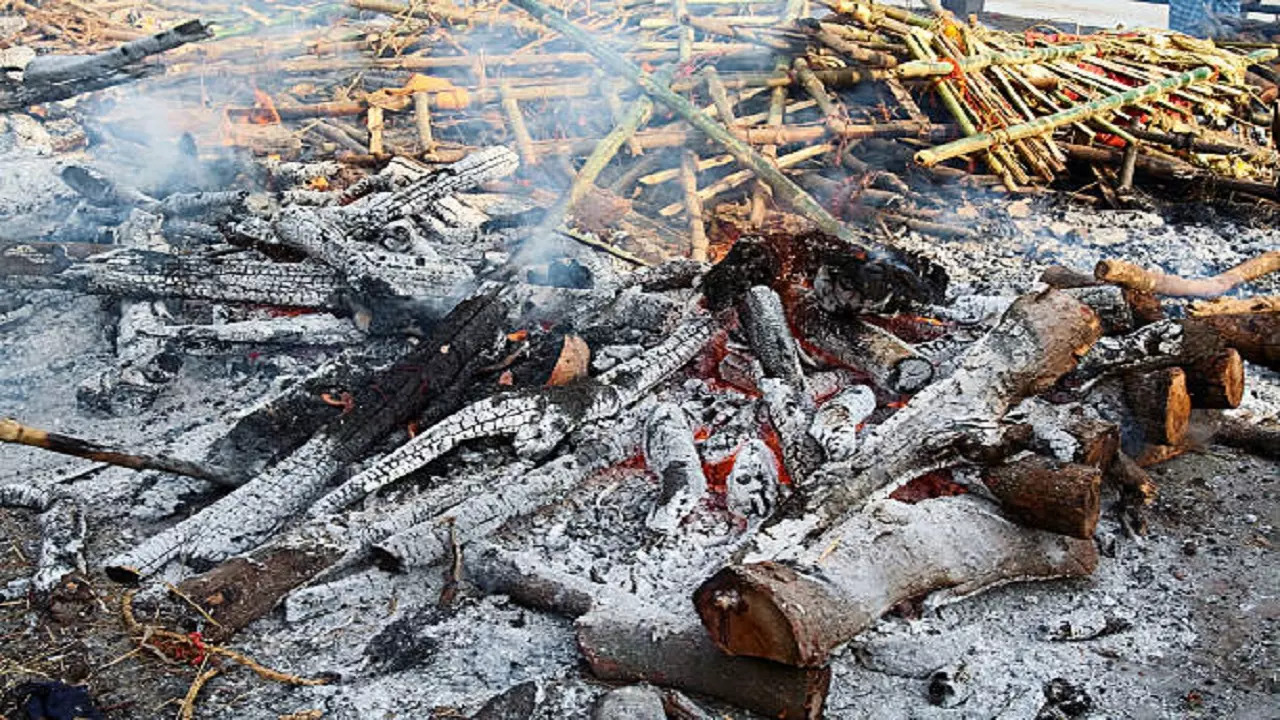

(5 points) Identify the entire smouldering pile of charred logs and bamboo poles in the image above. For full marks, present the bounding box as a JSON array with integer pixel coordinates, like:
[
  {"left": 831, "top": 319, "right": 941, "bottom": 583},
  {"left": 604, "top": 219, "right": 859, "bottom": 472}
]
[{"left": 0, "top": 0, "right": 1280, "bottom": 719}]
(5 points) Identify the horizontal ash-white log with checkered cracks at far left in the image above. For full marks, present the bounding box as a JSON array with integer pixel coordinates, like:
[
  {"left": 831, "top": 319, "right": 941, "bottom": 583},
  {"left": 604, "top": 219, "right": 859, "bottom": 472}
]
[{"left": 60, "top": 249, "right": 348, "bottom": 310}]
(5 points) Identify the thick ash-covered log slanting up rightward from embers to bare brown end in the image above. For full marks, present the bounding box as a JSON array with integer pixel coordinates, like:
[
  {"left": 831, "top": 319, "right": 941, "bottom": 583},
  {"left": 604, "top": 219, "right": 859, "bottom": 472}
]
[{"left": 758, "top": 290, "right": 1101, "bottom": 545}]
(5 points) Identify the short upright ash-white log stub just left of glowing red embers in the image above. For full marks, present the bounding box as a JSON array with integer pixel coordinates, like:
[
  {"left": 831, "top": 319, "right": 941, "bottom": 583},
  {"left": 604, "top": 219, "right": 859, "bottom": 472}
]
[{"left": 644, "top": 402, "right": 707, "bottom": 534}]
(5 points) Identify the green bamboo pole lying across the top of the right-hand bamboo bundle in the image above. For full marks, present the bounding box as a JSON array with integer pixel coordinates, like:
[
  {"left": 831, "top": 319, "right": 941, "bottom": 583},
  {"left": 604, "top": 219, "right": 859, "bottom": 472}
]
[{"left": 915, "top": 50, "right": 1275, "bottom": 167}]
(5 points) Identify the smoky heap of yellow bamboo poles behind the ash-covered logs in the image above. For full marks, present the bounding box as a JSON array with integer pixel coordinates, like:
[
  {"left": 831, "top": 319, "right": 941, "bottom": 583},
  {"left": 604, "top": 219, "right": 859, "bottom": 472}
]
[{"left": 10, "top": 0, "right": 1280, "bottom": 259}]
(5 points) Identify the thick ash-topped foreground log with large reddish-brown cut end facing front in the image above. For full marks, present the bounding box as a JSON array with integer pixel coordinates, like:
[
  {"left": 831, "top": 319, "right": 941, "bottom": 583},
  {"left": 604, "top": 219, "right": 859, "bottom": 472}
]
[{"left": 694, "top": 496, "right": 1097, "bottom": 667}]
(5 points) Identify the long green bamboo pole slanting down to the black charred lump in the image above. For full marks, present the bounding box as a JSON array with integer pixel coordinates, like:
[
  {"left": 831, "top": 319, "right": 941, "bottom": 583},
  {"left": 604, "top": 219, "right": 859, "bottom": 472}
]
[{"left": 511, "top": 0, "right": 868, "bottom": 258}]
